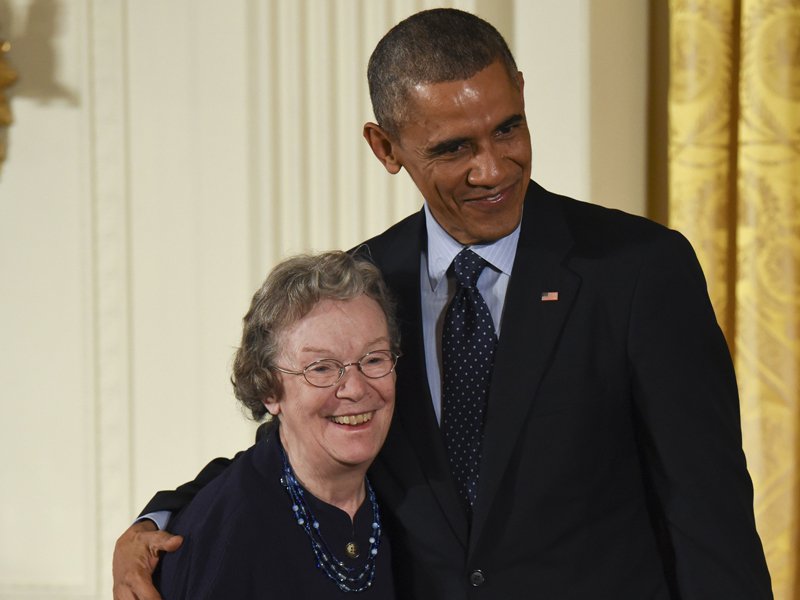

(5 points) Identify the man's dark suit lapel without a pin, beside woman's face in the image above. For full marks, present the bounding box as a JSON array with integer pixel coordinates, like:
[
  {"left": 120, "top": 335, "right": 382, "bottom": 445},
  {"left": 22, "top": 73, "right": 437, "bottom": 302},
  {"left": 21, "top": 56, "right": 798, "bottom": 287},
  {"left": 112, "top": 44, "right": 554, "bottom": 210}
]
[{"left": 367, "top": 211, "right": 469, "bottom": 548}]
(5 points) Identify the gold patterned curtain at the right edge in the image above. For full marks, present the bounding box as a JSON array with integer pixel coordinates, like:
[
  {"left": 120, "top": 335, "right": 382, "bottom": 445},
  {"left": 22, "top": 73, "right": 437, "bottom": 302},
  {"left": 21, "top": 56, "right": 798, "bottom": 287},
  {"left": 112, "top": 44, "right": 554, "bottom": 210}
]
[{"left": 668, "top": 0, "right": 800, "bottom": 600}]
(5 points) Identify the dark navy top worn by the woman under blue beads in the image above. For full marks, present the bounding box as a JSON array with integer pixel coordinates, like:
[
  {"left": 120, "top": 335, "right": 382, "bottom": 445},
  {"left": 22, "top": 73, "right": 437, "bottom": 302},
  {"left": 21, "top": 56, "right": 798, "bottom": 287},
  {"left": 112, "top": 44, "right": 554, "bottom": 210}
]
[{"left": 156, "top": 432, "right": 394, "bottom": 600}]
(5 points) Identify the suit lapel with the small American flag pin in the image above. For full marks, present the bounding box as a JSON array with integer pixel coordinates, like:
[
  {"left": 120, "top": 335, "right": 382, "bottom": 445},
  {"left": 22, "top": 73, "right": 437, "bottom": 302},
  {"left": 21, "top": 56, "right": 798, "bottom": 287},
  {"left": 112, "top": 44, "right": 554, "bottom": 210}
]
[{"left": 470, "top": 182, "right": 580, "bottom": 552}]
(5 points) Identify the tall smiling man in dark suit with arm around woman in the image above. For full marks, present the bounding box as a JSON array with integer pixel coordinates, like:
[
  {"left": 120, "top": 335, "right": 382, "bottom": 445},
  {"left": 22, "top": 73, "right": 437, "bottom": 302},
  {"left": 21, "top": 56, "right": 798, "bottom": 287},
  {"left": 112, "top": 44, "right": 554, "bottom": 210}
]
[{"left": 115, "top": 9, "right": 772, "bottom": 600}]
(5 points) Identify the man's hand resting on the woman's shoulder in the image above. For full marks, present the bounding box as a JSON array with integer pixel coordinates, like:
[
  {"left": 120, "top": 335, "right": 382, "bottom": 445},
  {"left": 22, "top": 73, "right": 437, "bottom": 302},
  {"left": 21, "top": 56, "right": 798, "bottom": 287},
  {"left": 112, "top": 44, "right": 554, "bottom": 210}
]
[{"left": 112, "top": 519, "right": 183, "bottom": 600}]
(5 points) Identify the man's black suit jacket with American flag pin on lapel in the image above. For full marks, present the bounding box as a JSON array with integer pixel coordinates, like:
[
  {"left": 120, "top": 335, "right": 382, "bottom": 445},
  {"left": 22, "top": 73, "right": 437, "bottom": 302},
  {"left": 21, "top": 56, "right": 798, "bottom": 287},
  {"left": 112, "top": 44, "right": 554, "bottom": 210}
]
[{"left": 145, "top": 182, "right": 772, "bottom": 600}]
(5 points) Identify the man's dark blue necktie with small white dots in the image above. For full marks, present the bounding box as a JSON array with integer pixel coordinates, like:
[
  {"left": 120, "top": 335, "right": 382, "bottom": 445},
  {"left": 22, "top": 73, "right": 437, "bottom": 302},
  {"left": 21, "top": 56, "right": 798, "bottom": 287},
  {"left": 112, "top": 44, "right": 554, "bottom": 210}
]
[{"left": 442, "top": 248, "right": 497, "bottom": 510}]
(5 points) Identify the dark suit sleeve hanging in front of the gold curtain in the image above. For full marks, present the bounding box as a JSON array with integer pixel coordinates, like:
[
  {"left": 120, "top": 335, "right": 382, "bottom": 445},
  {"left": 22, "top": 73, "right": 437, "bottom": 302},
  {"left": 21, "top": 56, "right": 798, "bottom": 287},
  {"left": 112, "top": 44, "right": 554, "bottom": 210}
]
[{"left": 628, "top": 232, "right": 772, "bottom": 600}]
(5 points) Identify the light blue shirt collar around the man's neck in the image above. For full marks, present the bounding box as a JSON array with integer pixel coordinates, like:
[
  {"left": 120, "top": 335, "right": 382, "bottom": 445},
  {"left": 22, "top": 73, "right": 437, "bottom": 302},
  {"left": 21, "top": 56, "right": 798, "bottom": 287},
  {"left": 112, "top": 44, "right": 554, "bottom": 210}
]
[{"left": 424, "top": 202, "right": 521, "bottom": 290}]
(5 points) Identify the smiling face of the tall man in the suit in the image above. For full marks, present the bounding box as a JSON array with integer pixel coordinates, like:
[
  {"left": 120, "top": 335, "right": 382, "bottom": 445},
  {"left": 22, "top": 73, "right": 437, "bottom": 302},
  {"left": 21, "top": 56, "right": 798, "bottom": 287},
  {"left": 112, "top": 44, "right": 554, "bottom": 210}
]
[{"left": 376, "top": 61, "right": 531, "bottom": 244}]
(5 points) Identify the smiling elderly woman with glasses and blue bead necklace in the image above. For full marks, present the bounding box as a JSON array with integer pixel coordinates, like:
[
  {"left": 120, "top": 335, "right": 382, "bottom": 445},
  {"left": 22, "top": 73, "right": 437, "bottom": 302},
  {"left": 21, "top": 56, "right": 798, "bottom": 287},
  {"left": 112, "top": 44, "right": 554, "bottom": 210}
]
[{"left": 159, "top": 252, "right": 399, "bottom": 600}]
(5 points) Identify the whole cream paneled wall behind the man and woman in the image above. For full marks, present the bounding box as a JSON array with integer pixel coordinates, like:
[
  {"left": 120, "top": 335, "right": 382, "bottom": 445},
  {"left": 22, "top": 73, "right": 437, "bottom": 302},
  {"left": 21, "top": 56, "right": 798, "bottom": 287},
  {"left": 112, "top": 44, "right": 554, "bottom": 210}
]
[{"left": 0, "top": 0, "right": 646, "bottom": 599}]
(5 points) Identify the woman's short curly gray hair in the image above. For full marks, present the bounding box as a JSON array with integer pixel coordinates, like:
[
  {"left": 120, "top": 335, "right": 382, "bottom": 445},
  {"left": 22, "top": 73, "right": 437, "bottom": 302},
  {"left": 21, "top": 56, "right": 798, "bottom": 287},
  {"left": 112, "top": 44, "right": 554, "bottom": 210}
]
[{"left": 231, "top": 251, "right": 400, "bottom": 421}]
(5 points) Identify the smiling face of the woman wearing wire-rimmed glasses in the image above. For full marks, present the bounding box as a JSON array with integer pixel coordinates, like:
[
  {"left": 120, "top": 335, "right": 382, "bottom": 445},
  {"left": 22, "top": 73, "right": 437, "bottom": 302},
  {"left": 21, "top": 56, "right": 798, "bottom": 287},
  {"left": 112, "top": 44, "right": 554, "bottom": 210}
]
[{"left": 266, "top": 296, "right": 396, "bottom": 477}]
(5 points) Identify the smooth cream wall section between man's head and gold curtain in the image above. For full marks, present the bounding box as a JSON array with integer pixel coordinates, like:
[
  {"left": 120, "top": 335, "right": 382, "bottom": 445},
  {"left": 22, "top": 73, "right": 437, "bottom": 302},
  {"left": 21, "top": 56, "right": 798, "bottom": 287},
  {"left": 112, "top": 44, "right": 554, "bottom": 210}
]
[{"left": 513, "top": 0, "right": 648, "bottom": 215}]
